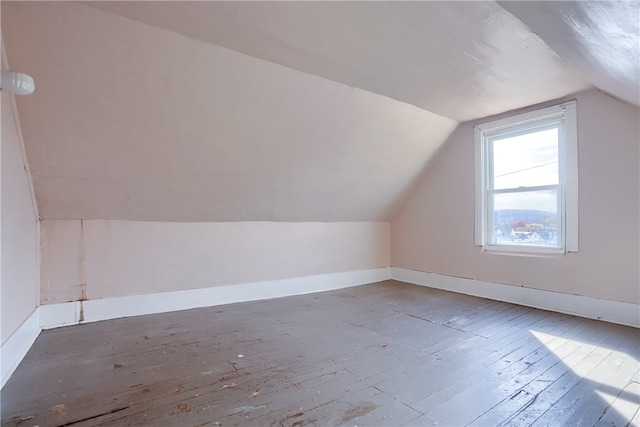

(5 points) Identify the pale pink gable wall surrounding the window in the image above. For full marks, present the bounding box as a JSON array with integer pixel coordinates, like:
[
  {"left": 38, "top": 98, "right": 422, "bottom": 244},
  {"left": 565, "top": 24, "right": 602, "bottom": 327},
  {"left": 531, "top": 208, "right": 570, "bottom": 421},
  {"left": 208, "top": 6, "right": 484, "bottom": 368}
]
[{"left": 391, "top": 90, "right": 640, "bottom": 303}]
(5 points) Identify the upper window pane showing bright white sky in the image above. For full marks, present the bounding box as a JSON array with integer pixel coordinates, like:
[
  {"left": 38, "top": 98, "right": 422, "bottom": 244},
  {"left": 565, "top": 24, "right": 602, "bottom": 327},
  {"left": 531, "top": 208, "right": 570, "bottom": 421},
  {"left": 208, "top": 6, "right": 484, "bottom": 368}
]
[{"left": 489, "top": 127, "right": 559, "bottom": 190}]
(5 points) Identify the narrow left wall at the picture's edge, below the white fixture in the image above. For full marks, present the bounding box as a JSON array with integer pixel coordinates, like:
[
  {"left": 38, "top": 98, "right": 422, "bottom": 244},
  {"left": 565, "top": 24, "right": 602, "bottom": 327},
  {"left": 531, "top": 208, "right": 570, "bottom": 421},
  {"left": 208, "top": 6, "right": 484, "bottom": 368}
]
[{"left": 0, "top": 93, "right": 38, "bottom": 343}]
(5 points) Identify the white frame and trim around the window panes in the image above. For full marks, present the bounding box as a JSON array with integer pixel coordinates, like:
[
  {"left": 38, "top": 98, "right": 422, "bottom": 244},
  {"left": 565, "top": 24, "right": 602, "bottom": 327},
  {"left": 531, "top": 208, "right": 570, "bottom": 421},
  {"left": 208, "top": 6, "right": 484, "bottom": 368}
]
[{"left": 474, "top": 100, "right": 578, "bottom": 253}]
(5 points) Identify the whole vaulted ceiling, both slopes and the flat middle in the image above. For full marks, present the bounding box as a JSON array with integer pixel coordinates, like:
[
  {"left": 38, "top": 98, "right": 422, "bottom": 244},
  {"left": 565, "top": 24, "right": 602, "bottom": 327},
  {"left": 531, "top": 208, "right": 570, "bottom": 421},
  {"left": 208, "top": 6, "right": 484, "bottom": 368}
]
[{"left": 1, "top": 1, "right": 638, "bottom": 221}]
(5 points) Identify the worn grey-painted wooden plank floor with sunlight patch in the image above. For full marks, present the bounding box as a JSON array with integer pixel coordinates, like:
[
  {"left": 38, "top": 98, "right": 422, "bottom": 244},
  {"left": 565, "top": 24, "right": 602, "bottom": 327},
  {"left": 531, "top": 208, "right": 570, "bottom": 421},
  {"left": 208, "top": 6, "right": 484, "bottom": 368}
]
[{"left": 1, "top": 281, "right": 640, "bottom": 427}]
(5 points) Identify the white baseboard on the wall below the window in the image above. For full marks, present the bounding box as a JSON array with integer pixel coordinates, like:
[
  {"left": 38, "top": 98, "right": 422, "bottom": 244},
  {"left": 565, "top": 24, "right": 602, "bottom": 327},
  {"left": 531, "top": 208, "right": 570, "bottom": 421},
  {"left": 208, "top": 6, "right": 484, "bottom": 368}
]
[{"left": 391, "top": 267, "right": 640, "bottom": 328}]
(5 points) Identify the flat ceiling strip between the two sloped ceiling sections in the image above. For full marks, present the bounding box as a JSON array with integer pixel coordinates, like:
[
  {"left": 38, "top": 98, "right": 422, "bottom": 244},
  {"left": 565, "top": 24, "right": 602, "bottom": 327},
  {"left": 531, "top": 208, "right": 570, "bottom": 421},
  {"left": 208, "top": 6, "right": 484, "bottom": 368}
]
[{"left": 87, "top": 1, "right": 588, "bottom": 121}]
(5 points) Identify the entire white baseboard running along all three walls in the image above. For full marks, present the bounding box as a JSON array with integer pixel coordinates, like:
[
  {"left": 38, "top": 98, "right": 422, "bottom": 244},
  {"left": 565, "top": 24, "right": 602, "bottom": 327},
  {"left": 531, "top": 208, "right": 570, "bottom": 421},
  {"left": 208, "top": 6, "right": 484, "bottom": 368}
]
[{"left": 8, "top": 267, "right": 640, "bottom": 387}]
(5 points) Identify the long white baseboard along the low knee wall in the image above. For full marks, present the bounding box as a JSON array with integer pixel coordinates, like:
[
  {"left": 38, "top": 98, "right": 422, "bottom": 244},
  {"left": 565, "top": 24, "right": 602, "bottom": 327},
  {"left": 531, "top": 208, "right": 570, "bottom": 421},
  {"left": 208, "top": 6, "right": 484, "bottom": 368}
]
[{"left": 40, "top": 267, "right": 391, "bottom": 329}]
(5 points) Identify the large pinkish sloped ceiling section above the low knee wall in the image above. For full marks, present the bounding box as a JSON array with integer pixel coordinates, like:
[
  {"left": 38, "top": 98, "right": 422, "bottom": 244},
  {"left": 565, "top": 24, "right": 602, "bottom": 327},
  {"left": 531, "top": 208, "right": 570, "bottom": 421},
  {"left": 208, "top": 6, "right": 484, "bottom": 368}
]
[{"left": 2, "top": 2, "right": 456, "bottom": 221}]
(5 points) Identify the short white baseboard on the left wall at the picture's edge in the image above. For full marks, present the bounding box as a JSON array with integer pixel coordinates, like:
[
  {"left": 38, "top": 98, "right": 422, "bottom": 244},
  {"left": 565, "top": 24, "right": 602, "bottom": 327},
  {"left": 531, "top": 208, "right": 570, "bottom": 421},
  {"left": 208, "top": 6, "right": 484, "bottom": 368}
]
[{"left": 0, "top": 308, "right": 41, "bottom": 388}]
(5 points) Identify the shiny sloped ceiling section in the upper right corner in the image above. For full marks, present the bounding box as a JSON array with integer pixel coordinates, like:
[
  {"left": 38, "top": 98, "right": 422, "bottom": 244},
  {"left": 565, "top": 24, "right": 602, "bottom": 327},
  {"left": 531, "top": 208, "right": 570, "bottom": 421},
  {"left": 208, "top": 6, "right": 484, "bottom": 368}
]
[{"left": 500, "top": 0, "right": 640, "bottom": 105}]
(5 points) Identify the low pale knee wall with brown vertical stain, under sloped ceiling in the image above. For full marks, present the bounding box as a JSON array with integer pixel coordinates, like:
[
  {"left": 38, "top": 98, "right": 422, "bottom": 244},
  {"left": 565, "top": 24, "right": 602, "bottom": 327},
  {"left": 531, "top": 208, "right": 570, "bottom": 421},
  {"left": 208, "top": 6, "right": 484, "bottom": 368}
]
[{"left": 41, "top": 220, "right": 390, "bottom": 304}]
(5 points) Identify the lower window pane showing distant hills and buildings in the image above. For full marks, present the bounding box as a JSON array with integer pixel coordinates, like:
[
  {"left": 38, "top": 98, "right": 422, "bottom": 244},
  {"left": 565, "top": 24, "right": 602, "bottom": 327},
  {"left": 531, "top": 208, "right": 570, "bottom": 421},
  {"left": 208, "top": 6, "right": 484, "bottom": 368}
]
[{"left": 489, "top": 189, "right": 560, "bottom": 248}]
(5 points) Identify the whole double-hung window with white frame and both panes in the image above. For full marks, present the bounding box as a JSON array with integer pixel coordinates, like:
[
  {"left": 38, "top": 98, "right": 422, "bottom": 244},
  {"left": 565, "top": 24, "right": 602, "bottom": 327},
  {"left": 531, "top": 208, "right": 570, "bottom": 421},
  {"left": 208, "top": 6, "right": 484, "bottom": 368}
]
[{"left": 474, "top": 101, "right": 578, "bottom": 253}]
